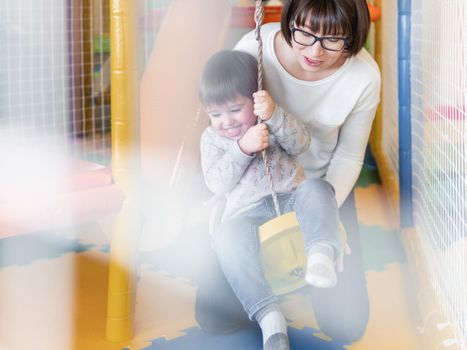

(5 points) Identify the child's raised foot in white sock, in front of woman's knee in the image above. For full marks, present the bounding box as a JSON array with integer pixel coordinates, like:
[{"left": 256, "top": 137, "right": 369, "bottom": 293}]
[{"left": 305, "top": 243, "right": 337, "bottom": 288}]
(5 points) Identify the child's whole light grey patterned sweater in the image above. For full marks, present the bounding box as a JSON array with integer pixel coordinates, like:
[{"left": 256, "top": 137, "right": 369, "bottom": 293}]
[{"left": 201, "top": 105, "right": 311, "bottom": 220}]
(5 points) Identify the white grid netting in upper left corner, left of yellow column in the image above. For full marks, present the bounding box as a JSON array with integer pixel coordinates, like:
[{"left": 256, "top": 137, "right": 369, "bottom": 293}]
[{"left": 0, "top": 0, "right": 110, "bottom": 161}]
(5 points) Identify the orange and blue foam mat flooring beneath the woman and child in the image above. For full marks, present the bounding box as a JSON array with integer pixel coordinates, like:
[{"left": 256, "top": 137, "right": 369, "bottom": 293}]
[{"left": 0, "top": 168, "right": 421, "bottom": 350}]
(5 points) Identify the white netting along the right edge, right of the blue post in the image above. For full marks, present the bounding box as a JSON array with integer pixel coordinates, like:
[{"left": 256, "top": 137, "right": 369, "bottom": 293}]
[{"left": 411, "top": 0, "right": 467, "bottom": 349}]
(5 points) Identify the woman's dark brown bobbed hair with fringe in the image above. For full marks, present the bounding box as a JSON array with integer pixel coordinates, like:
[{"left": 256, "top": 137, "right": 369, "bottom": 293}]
[{"left": 281, "top": 0, "right": 370, "bottom": 55}]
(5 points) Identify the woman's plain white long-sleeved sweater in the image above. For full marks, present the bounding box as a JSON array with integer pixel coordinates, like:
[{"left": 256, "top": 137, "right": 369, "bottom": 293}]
[{"left": 235, "top": 23, "right": 380, "bottom": 205}]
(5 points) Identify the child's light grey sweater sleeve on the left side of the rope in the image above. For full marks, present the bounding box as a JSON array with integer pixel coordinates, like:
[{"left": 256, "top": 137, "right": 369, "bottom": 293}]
[{"left": 200, "top": 128, "right": 254, "bottom": 194}]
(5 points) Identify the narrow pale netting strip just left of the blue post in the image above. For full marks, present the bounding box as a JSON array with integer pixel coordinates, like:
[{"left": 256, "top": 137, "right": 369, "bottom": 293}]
[{"left": 381, "top": 1, "right": 399, "bottom": 179}]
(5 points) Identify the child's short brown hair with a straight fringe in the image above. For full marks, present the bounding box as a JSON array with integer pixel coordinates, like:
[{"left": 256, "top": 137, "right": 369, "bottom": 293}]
[{"left": 199, "top": 50, "right": 258, "bottom": 106}]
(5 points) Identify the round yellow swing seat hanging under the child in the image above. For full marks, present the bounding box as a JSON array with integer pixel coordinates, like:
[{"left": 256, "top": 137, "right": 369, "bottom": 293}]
[{"left": 259, "top": 212, "right": 307, "bottom": 295}]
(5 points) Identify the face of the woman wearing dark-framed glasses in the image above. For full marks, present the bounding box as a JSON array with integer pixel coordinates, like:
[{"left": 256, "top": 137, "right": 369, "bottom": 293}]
[{"left": 292, "top": 26, "right": 347, "bottom": 79}]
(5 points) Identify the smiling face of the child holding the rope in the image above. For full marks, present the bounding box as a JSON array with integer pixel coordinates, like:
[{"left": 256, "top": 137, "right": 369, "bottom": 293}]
[{"left": 206, "top": 95, "right": 257, "bottom": 140}]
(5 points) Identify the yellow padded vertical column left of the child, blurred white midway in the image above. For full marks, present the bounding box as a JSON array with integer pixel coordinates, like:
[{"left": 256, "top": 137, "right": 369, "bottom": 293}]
[{"left": 106, "top": 0, "right": 140, "bottom": 342}]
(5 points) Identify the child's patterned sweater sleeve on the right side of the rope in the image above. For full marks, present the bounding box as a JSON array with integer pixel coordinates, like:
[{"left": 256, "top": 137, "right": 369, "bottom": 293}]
[{"left": 266, "top": 105, "right": 311, "bottom": 156}]
